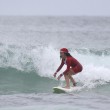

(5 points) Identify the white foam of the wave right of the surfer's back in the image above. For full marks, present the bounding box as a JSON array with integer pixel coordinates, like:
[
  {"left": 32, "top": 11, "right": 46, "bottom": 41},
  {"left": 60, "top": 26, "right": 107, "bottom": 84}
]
[{"left": 75, "top": 54, "right": 110, "bottom": 88}]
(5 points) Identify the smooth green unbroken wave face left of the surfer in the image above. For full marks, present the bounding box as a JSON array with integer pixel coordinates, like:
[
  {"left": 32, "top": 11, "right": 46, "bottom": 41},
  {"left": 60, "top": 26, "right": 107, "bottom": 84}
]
[{"left": 0, "top": 68, "right": 58, "bottom": 94}]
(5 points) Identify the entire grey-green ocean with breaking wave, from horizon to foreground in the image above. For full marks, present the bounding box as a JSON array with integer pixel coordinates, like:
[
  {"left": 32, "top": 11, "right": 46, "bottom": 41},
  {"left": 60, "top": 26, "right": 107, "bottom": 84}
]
[{"left": 0, "top": 16, "right": 110, "bottom": 110}]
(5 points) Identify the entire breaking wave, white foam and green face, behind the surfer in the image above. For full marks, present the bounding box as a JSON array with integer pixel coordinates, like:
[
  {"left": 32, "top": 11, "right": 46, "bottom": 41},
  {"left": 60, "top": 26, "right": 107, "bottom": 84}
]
[{"left": 0, "top": 44, "right": 110, "bottom": 92}]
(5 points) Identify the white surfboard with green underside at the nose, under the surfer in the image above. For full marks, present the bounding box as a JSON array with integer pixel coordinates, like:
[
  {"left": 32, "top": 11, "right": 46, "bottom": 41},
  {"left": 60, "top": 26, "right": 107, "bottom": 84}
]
[{"left": 53, "top": 86, "right": 81, "bottom": 93}]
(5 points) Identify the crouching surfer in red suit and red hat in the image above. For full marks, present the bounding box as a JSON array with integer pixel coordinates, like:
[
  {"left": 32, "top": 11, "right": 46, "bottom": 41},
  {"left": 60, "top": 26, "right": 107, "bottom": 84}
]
[{"left": 53, "top": 48, "right": 83, "bottom": 89}]
